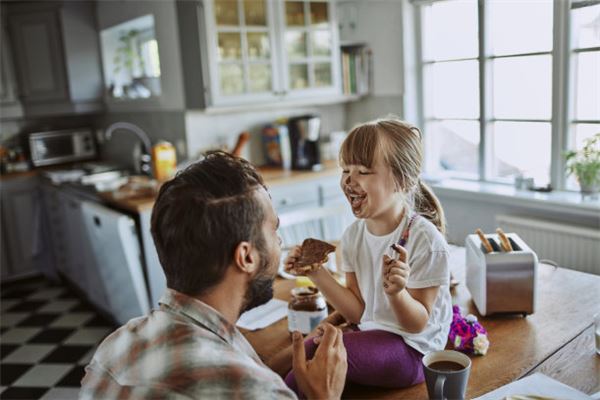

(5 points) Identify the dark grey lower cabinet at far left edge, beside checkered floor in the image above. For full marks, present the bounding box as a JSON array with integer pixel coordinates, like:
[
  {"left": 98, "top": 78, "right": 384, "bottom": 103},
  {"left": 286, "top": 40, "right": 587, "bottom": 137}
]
[{"left": 0, "top": 176, "right": 48, "bottom": 279}]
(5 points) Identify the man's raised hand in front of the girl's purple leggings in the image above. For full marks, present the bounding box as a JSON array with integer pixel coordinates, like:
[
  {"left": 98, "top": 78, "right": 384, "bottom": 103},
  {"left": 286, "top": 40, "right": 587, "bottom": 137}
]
[{"left": 292, "top": 324, "right": 348, "bottom": 399}]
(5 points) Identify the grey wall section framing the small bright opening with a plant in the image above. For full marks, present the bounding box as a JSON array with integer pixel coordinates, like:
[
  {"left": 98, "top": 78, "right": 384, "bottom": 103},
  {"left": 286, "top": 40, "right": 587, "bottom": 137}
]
[{"left": 96, "top": 0, "right": 185, "bottom": 112}]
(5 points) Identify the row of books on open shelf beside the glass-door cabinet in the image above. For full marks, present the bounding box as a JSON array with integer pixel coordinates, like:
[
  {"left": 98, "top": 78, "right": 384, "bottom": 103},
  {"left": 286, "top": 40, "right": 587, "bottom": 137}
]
[{"left": 341, "top": 45, "right": 372, "bottom": 96}]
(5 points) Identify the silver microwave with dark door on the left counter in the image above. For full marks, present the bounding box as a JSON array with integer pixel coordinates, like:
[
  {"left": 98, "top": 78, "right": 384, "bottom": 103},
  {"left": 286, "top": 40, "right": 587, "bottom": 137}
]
[{"left": 29, "top": 128, "right": 97, "bottom": 167}]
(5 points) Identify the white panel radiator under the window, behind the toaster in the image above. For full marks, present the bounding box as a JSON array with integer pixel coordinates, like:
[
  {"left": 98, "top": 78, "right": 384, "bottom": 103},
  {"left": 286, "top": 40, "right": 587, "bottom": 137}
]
[{"left": 496, "top": 215, "right": 600, "bottom": 275}]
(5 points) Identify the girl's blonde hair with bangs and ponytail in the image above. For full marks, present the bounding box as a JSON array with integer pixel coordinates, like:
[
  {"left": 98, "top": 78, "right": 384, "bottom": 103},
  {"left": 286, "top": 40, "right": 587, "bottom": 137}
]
[{"left": 340, "top": 117, "right": 446, "bottom": 234}]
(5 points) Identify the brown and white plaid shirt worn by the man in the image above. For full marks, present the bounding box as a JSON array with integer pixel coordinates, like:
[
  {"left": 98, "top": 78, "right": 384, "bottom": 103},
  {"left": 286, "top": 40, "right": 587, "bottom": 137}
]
[{"left": 80, "top": 289, "right": 296, "bottom": 399}]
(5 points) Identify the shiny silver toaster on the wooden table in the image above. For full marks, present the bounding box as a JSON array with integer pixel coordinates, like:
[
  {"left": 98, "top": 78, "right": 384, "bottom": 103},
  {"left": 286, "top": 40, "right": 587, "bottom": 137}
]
[{"left": 465, "top": 233, "right": 538, "bottom": 316}]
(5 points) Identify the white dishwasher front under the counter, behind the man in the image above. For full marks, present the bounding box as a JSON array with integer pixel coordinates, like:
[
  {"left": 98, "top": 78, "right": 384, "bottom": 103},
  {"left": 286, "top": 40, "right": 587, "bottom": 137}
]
[{"left": 81, "top": 201, "right": 150, "bottom": 324}]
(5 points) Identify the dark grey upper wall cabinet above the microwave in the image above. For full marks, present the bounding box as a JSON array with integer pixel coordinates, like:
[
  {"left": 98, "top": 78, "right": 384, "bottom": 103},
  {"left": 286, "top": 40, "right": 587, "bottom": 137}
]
[{"left": 6, "top": 1, "right": 103, "bottom": 116}]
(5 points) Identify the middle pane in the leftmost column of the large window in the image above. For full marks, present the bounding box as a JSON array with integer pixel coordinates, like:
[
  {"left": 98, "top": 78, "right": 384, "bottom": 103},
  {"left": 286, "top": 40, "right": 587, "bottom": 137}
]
[{"left": 425, "top": 61, "right": 479, "bottom": 118}]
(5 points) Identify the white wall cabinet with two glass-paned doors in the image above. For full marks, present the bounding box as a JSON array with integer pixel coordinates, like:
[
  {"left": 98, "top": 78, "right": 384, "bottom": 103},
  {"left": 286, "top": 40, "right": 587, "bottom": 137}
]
[{"left": 177, "top": 0, "right": 341, "bottom": 108}]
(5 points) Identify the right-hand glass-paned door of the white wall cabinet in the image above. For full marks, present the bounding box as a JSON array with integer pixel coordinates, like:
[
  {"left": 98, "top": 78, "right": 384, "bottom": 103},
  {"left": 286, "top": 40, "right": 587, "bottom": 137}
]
[{"left": 283, "top": 0, "right": 337, "bottom": 92}]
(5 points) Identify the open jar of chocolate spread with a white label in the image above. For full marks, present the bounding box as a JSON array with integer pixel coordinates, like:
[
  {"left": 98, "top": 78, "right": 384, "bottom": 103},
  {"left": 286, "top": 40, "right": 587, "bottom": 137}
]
[{"left": 288, "top": 286, "right": 328, "bottom": 335}]
